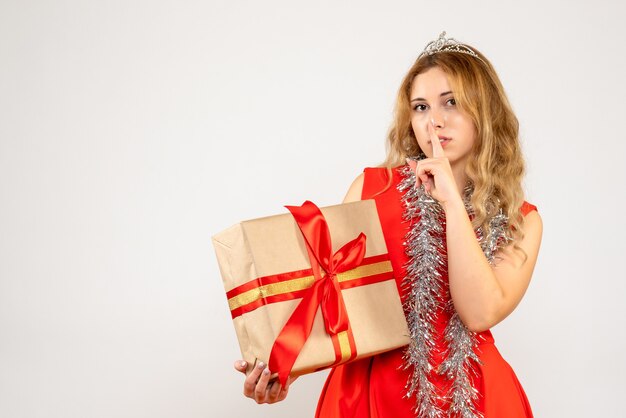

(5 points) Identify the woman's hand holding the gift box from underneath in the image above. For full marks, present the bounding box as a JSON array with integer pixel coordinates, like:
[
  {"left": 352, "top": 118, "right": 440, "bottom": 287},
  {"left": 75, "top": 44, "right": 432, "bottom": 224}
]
[{"left": 235, "top": 360, "right": 297, "bottom": 404}]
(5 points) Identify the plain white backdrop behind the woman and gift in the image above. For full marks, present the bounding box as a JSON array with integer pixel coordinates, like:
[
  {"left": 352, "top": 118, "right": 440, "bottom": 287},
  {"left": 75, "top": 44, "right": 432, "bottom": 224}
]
[{"left": 0, "top": 0, "right": 626, "bottom": 418}]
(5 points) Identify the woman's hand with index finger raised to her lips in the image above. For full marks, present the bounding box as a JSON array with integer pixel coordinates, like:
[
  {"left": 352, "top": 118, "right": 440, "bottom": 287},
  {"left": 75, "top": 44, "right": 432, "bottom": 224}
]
[{"left": 407, "top": 123, "right": 460, "bottom": 205}]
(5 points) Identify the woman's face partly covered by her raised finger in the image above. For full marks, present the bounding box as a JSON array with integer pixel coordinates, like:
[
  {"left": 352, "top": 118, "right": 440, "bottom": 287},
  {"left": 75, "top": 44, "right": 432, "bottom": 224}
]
[{"left": 410, "top": 67, "right": 476, "bottom": 167}]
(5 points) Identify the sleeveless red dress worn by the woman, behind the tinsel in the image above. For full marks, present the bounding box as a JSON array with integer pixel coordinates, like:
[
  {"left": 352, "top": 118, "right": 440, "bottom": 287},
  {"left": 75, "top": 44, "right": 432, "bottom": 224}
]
[{"left": 315, "top": 168, "right": 536, "bottom": 418}]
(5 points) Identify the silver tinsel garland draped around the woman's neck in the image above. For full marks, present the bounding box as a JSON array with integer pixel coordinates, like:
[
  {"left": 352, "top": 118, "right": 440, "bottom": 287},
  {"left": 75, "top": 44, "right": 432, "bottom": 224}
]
[{"left": 398, "top": 161, "right": 510, "bottom": 418}]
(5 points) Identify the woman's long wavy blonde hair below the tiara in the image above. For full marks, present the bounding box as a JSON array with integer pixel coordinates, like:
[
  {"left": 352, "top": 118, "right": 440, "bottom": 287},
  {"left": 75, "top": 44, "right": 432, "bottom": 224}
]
[{"left": 383, "top": 48, "right": 524, "bottom": 248}]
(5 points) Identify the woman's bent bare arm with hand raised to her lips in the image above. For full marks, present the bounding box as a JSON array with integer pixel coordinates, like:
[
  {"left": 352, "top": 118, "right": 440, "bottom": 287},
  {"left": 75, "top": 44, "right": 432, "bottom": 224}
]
[{"left": 409, "top": 124, "right": 542, "bottom": 331}]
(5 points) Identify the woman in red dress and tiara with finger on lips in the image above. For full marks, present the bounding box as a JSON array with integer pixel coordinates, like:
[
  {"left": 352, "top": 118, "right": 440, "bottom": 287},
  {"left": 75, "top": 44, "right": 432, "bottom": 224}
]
[{"left": 235, "top": 32, "right": 542, "bottom": 418}]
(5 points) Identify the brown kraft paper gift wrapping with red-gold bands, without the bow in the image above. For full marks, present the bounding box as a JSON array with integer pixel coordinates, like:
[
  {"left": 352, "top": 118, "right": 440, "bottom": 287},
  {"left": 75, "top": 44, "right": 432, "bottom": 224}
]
[{"left": 213, "top": 200, "right": 409, "bottom": 375}]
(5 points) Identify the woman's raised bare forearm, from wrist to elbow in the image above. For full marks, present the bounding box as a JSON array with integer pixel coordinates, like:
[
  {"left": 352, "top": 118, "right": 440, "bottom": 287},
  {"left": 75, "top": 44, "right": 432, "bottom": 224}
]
[{"left": 443, "top": 199, "right": 504, "bottom": 331}]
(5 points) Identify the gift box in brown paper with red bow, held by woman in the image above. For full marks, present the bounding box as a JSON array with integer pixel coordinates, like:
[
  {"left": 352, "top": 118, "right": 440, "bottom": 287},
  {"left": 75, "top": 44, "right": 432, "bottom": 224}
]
[{"left": 213, "top": 200, "right": 409, "bottom": 383}]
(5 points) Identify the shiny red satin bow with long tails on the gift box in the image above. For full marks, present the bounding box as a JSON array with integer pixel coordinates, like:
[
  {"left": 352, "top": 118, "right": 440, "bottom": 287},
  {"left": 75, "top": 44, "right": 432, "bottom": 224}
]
[{"left": 269, "top": 200, "right": 365, "bottom": 386}]
